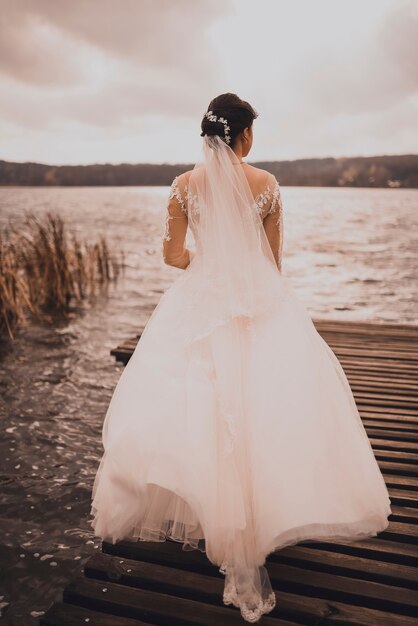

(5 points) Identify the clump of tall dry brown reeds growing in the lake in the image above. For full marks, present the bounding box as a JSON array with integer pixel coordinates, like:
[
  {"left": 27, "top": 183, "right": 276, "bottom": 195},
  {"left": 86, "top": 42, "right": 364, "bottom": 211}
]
[{"left": 0, "top": 211, "right": 124, "bottom": 338}]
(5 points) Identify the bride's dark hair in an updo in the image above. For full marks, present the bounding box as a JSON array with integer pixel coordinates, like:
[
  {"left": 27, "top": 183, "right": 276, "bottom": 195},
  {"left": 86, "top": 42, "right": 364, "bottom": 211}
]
[{"left": 200, "top": 93, "right": 258, "bottom": 148}]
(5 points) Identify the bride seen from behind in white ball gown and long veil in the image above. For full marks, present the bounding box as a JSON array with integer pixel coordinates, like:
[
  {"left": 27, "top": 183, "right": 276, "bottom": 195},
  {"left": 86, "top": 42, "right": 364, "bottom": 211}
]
[{"left": 91, "top": 93, "right": 392, "bottom": 622}]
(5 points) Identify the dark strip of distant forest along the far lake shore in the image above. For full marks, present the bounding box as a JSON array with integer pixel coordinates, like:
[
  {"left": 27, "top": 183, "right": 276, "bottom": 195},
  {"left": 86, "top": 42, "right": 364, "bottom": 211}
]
[{"left": 0, "top": 154, "right": 418, "bottom": 188}]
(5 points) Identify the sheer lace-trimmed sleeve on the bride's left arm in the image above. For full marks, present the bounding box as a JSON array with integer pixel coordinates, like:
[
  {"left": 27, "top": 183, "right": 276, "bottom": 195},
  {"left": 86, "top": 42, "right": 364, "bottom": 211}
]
[{"left": 163, "top": 176, "right": 191, "bottom": 269}]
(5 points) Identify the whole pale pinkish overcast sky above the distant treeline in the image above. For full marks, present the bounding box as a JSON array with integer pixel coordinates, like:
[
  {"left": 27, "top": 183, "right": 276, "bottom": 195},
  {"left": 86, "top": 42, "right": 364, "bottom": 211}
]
[{"left": 0, "top": 0, "right": 418, "bottom": 164}]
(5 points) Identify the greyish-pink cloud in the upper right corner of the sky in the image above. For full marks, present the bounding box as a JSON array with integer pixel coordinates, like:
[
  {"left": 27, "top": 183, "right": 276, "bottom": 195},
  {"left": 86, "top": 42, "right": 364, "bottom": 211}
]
[{"left": 294, "top": 1, "right": 418, "bottom": 116}]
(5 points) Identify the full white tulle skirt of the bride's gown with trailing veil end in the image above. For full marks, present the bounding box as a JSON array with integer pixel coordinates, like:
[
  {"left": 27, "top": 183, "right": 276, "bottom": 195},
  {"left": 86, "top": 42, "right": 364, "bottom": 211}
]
[{"left": 91, "top": 264, "right": 391, "bottom": 622}]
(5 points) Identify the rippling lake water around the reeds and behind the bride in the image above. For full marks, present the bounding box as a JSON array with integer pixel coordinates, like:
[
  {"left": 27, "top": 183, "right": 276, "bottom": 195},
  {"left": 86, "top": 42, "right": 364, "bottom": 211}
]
[{"left": 0, "top": 187, "right": 418, "bottom": 626}]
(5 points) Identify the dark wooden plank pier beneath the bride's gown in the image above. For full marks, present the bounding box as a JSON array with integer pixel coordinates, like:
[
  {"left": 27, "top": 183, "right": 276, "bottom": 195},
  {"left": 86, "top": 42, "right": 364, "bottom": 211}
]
[{"left": 40, "top": 320, "right": 418, "bottom": 626}]
